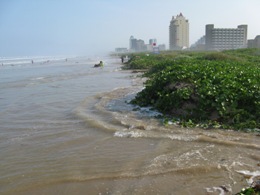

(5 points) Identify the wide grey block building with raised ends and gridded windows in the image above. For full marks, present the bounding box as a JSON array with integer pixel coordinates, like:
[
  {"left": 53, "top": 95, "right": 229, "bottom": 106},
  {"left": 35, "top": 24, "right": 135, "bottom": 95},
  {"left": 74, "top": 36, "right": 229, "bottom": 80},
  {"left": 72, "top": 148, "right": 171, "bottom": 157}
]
[{"left": 205, "top": 24, "right": 247, "bottom": 50}]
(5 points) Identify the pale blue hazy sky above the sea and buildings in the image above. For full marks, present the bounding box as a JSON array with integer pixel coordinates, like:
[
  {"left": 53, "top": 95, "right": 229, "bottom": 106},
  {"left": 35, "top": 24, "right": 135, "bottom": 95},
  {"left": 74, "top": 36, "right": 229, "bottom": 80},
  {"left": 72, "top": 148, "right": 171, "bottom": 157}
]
[{"left": 0, "top": 0, "right": 260, "bottom": 57}]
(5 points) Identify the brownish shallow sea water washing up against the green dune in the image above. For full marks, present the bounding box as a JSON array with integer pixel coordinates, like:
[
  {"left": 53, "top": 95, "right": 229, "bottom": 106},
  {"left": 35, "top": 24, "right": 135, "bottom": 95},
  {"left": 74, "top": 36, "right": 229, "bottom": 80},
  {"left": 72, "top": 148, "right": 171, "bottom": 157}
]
[{"left": 0, "top": 57, "right": 260, "bottom": 194}]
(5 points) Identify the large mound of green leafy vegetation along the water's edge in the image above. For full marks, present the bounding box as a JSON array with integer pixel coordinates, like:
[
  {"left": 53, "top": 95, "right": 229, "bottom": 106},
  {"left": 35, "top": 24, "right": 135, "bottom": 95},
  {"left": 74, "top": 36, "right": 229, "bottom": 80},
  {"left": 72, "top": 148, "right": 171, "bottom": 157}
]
[{"left": 124, "top": 49, "right": 260, "bottom": 132}]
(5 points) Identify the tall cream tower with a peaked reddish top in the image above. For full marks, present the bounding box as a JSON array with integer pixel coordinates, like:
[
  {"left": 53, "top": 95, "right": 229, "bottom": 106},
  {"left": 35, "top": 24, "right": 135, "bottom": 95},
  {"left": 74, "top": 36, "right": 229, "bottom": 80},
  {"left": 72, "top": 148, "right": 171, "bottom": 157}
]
[{"left": 169, "top": 13, "right": 189, "bottom": 50}]
